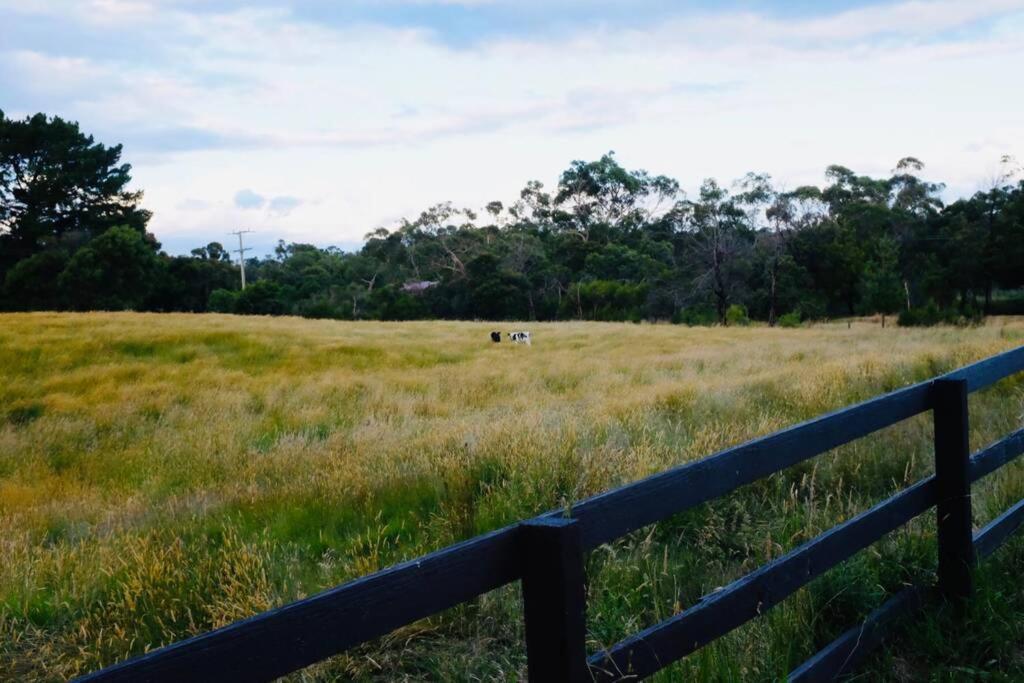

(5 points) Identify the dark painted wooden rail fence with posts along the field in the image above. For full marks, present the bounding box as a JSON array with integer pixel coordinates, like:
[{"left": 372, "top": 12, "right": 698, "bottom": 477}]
[{"left": 82, "top": 346, "right": 1024, "bottom": 682}]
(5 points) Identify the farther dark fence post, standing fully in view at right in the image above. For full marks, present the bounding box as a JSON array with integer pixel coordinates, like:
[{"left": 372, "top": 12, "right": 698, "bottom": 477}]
[{"left": 933, "top": 379, "right": 975, "bottom": 598}]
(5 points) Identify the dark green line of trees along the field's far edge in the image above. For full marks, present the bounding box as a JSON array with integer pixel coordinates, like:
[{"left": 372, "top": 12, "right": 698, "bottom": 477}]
[{"left": 6, "top": 112, "right": 1024, "bottom": 325}]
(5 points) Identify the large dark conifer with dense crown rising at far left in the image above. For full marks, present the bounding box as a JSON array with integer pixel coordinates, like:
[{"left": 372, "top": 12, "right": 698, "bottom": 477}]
[{"left": 0, "top": 112, "right": 150, "bottom": 276}]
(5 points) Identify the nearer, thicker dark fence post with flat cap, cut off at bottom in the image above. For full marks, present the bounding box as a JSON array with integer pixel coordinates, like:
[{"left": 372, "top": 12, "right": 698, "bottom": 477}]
[{"left": 520, "top": 517, "right": 591, "bottom": 683}]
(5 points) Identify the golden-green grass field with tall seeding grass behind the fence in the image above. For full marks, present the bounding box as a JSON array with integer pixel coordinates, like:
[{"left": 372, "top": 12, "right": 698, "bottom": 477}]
[{"left": 0, "top": 313, "right": 1024, "bottom": 681}]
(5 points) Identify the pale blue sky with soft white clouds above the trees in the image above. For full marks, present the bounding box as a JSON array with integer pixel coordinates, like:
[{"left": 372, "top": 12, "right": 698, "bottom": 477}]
[{"left": 0, "top": 0, "right": 1024, "bottom": 255}]
